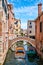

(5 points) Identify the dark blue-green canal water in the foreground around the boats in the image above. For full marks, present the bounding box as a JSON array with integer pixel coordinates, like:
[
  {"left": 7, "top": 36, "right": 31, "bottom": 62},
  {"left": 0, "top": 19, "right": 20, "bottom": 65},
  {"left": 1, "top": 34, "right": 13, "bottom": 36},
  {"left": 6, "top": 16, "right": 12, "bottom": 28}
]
[{"left": 4, "top": 41, "right": 43, "bottom": 65}]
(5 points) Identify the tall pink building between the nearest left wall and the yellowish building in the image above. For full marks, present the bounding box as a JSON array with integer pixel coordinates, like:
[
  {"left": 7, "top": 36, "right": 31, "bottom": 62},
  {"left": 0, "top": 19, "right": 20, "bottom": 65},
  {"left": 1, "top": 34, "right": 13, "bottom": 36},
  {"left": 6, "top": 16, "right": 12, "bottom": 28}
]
[{"left": 8, "top": 4, "right": 14, "bottom": 39}]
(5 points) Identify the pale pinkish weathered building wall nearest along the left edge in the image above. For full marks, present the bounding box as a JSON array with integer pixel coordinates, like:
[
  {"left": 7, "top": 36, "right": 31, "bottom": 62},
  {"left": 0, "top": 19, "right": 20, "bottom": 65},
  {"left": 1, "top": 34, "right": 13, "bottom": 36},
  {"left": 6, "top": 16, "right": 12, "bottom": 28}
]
[{"left": 0, "top": 0, "right": 8, "bottom": 64}]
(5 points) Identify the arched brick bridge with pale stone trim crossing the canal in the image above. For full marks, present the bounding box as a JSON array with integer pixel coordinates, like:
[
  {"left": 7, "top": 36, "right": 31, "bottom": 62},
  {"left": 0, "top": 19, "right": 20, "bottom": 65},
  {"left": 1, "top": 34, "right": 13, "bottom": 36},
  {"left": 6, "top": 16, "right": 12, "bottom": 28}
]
[{"left": 9, "top": 37, "right": 36, "bottom": 48}]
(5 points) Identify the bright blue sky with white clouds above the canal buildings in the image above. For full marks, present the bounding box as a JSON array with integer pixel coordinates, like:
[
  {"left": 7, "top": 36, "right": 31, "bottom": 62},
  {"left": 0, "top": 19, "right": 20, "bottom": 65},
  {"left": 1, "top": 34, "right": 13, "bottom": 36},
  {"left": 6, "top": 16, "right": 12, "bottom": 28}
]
[{"left": 8, "top": 0, "right": 43, "bottom": 29}]
